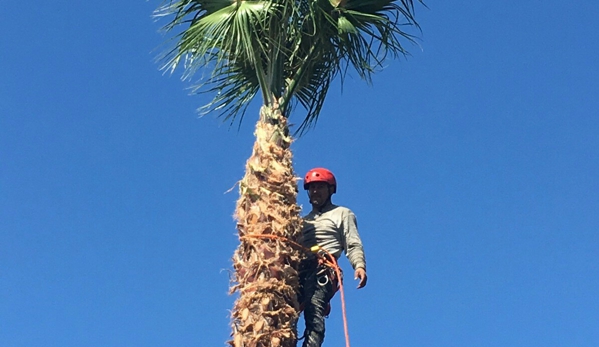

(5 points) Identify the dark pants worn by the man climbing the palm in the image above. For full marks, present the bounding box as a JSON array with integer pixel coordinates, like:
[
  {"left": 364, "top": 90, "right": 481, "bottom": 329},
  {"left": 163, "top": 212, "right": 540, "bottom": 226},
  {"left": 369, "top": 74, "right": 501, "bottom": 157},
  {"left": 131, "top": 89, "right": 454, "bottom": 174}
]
[{"left": 299, "top": 260, "right": 335, "bottom": 347}]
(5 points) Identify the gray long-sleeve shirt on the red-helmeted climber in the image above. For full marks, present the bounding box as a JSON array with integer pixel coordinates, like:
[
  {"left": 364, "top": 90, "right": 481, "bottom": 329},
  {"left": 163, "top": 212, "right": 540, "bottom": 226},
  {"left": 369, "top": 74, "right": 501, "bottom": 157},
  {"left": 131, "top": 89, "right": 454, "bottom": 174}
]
[{"left": 302, "top": 204, "right": 366, "bottom": 270}]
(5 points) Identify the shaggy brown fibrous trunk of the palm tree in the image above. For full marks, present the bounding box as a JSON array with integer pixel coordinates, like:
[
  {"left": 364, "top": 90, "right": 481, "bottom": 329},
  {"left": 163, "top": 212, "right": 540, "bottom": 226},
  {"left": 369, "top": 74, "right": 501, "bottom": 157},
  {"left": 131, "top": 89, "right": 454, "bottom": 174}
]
[{"left": 229, "top": 106, "right": 301, "bottom": 347}]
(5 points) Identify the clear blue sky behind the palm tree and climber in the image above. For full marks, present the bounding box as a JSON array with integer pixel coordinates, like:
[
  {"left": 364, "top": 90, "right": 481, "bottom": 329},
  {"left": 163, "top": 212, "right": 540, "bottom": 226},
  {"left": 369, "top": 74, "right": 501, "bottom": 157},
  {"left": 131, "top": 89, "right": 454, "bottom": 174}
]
[{"left": 0, "top": 0, "right": 599, "bottom": 347}]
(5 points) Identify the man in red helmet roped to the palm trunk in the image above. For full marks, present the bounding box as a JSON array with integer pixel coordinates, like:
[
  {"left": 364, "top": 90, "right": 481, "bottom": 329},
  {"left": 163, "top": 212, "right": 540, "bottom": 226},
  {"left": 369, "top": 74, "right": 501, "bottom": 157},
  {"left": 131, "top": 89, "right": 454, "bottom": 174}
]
[{"left": 299, "top": 168, "right": 368, "bottom": 347}]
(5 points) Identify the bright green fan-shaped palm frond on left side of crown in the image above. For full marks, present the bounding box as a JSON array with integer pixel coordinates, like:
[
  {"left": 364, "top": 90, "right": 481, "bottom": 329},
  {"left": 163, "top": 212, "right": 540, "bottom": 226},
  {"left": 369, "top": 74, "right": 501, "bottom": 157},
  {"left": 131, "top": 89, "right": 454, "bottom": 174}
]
[{"left": 156, "top": 0, "right": 282, "bottom": 119}]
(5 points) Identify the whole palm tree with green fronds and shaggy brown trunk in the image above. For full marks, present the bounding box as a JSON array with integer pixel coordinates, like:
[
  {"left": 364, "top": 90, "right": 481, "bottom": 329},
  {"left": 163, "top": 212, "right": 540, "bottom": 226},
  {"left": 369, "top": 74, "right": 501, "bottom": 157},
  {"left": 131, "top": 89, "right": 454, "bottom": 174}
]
[{"left": 155, "top": 0, "right": 421, "bottom": 347}]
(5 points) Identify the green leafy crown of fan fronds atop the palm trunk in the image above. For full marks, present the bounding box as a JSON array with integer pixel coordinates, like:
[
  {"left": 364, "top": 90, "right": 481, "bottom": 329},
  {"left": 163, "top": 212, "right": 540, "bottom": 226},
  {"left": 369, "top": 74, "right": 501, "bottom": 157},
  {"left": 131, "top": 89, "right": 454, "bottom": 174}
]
[{"left": 155, "top": 0, "right": 421, "bottom": 132}]
